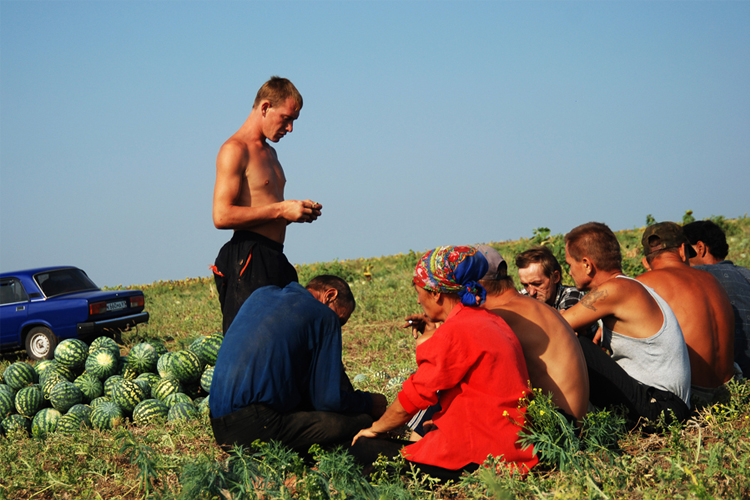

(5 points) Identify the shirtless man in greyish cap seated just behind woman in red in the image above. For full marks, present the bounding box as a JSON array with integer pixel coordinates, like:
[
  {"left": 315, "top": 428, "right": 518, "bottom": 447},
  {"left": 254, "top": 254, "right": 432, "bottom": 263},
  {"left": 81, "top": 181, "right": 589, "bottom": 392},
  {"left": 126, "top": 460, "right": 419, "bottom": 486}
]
[{"left": 477, "top": 245, "right": 589, "bottom": 423}]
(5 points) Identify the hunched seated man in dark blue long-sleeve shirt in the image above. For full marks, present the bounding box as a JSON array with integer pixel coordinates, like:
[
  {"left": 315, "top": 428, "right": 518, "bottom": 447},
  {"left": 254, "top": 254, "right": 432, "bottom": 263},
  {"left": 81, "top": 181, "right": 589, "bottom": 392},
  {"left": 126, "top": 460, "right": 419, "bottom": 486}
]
[{"left": 209, "top": 275, "right": 387, "bottom": 454}]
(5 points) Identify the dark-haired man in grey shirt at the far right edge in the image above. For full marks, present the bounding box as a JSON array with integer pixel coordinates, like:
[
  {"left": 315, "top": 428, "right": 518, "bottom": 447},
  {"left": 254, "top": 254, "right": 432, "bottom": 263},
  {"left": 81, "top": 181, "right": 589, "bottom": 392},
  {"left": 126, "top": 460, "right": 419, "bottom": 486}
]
[{"left": 682, "top": 220, "right": 750, "bottom": 376}]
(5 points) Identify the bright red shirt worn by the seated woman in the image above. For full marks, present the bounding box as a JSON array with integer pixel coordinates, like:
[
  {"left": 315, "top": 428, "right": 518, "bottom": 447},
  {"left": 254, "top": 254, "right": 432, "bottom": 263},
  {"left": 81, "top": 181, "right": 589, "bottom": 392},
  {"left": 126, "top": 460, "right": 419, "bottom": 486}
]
[{"left": 398, "top": 304, "right": 538, "bottom": 472}]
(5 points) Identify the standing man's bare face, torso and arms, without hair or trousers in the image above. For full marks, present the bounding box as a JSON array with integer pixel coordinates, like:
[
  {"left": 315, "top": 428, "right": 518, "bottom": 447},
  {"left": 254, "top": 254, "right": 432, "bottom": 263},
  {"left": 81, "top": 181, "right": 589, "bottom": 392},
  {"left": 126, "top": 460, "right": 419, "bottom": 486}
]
[{"left": 213, "top": 94, "right": 322, "bottom": 243}]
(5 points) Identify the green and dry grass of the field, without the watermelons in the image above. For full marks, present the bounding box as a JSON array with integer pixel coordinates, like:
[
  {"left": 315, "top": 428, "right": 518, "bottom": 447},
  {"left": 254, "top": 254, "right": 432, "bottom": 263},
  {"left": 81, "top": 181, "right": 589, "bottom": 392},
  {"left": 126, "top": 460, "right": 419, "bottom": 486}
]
[{"left": 0, "top": 217, "right": 750, "bottom": 499}]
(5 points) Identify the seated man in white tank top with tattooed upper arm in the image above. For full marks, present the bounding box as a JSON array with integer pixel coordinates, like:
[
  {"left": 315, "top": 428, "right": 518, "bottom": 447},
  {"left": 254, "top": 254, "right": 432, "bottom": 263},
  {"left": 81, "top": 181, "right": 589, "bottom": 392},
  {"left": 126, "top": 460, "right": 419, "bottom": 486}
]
[{"left": 562, "top": 222, "right": 690, "bottom": 424}]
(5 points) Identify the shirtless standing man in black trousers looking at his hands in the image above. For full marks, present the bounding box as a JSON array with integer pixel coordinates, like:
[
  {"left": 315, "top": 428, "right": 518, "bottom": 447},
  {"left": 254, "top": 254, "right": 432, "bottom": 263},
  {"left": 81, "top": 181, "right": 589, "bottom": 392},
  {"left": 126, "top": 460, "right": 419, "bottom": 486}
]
[{"left": 212, "top": 76, "right": 322, "bottom": 333}]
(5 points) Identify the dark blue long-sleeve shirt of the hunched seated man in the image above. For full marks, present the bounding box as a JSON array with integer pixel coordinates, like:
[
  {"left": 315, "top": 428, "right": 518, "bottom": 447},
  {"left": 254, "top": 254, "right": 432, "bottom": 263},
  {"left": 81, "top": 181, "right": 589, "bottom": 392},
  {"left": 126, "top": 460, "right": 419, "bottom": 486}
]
[{"left": 209, "top": 283, "right": 372, "bottom": 418}]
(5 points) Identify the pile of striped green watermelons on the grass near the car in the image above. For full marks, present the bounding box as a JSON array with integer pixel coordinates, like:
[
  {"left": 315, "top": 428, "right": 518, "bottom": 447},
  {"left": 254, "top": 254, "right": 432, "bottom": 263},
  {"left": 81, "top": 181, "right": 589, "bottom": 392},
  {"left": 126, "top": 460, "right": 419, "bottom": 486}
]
[{"left": 0, "top": 333, "right": 224, "bottom": 438}]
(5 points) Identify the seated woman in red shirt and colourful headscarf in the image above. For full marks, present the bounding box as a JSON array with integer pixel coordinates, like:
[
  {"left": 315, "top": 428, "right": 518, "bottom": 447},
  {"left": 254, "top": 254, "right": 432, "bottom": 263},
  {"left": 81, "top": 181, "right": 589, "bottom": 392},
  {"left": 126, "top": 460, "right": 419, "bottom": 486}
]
[{"left": 350, "top": 246, "right": 538, "bottom": 479}]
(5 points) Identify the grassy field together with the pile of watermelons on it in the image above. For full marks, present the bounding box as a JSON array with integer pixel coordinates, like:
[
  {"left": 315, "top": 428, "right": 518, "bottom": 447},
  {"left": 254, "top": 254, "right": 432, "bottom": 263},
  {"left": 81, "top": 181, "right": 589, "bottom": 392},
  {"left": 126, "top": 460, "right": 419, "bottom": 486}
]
[{"left": 0, "top": 213, "right": 750, "bottom": 500}]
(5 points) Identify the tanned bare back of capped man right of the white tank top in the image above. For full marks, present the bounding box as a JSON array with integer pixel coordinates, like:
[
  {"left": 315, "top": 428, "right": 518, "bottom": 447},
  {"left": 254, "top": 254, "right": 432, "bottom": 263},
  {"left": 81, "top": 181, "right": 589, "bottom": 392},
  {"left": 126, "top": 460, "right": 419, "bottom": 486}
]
[{"left": 637, "top": 254, "right": 734, "bottom": 388}]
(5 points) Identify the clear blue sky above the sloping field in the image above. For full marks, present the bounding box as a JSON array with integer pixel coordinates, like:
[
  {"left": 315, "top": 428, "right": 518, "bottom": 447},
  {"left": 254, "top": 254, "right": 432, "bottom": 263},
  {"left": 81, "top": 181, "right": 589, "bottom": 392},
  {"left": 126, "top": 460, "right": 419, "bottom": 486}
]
[{"left": 0, "top": 0, "right": 750, "bottom": 286}]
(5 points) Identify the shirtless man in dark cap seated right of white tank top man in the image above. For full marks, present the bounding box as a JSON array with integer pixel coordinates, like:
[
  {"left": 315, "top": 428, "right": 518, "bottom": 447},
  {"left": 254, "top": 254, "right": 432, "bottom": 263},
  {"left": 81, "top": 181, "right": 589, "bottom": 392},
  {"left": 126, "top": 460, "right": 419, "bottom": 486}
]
[{"left": 637, "top": 222, "right": 734, "bottom": 404}]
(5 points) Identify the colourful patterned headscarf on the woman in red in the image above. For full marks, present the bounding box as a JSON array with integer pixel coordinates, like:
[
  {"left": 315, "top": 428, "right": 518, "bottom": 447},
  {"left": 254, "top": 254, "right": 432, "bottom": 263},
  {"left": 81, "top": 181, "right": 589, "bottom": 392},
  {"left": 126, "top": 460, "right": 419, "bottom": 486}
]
[{"left": 413, "top": 246, "right": 489, "bottom": 306}]
